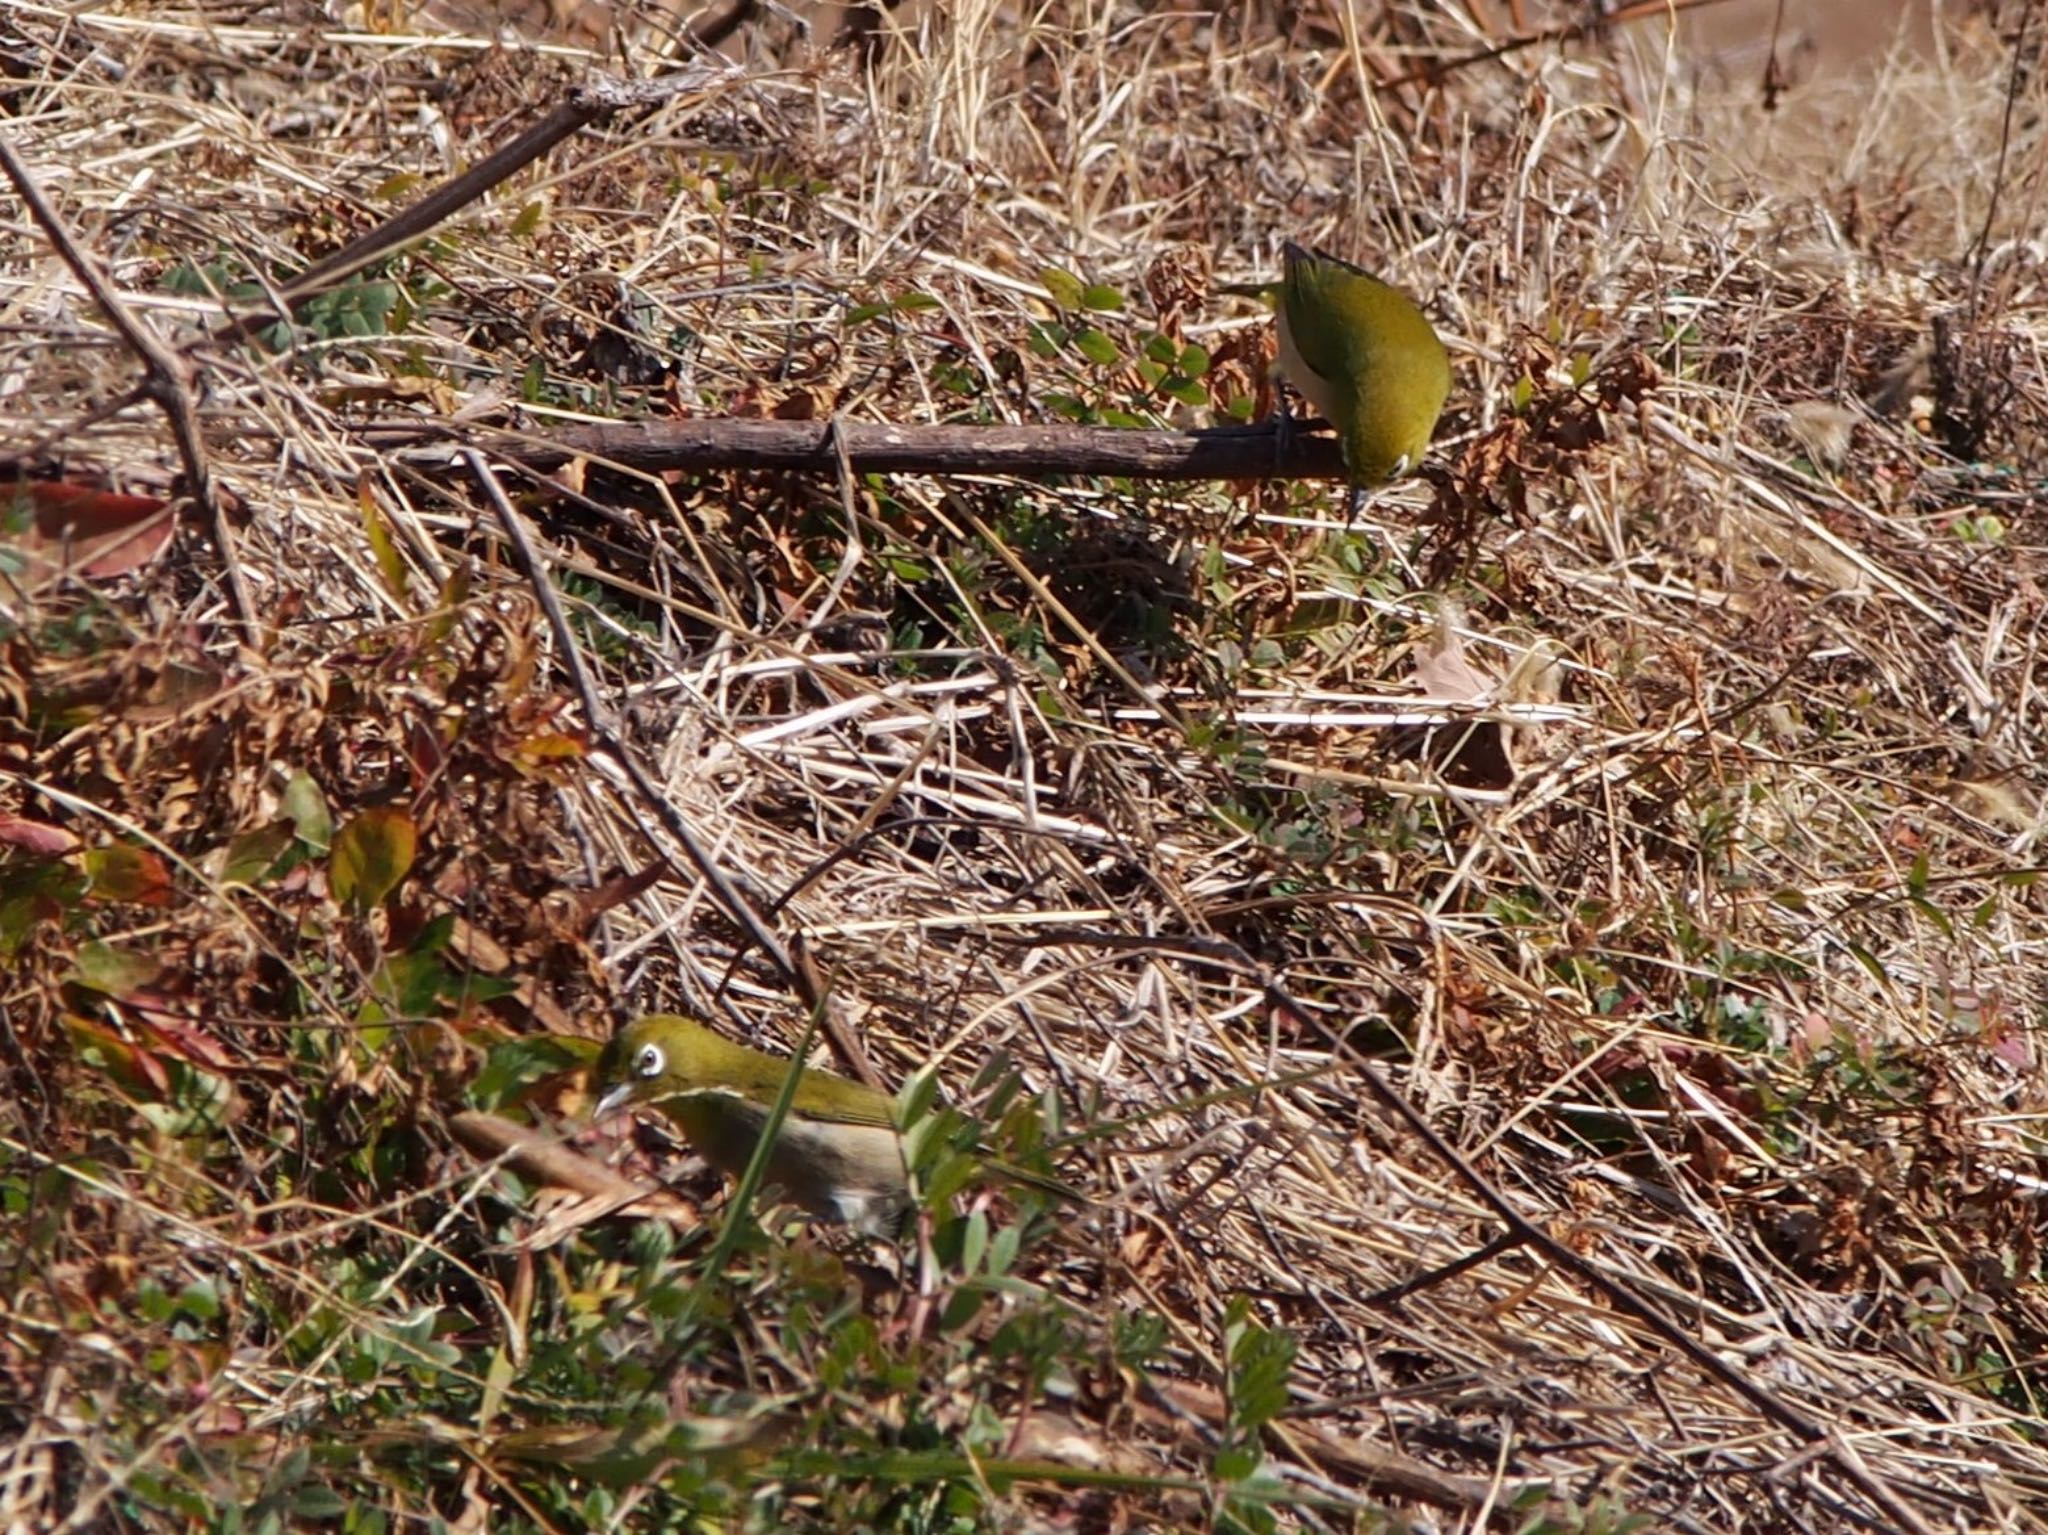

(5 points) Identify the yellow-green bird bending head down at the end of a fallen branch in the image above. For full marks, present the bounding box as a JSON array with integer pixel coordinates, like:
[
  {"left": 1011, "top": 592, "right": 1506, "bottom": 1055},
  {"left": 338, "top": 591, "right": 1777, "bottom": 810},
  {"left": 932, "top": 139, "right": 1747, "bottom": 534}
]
[{"left": 1274, "top": 239, "right": 1450, "bottom": 485}]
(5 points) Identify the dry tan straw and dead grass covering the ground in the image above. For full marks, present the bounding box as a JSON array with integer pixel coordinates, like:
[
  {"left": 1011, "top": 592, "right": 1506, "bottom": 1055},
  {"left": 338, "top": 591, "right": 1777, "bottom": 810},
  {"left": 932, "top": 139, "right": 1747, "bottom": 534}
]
[{"left": 0, "top": 0, "right": 2048, "bottom": 1531}]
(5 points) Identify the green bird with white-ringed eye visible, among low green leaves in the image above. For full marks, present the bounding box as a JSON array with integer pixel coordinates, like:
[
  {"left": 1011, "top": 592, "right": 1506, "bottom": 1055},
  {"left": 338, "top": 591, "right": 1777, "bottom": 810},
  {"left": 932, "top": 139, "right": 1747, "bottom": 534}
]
[{"left": 594, "top": 1013, "right": 1081, "bottom": 1236}]
